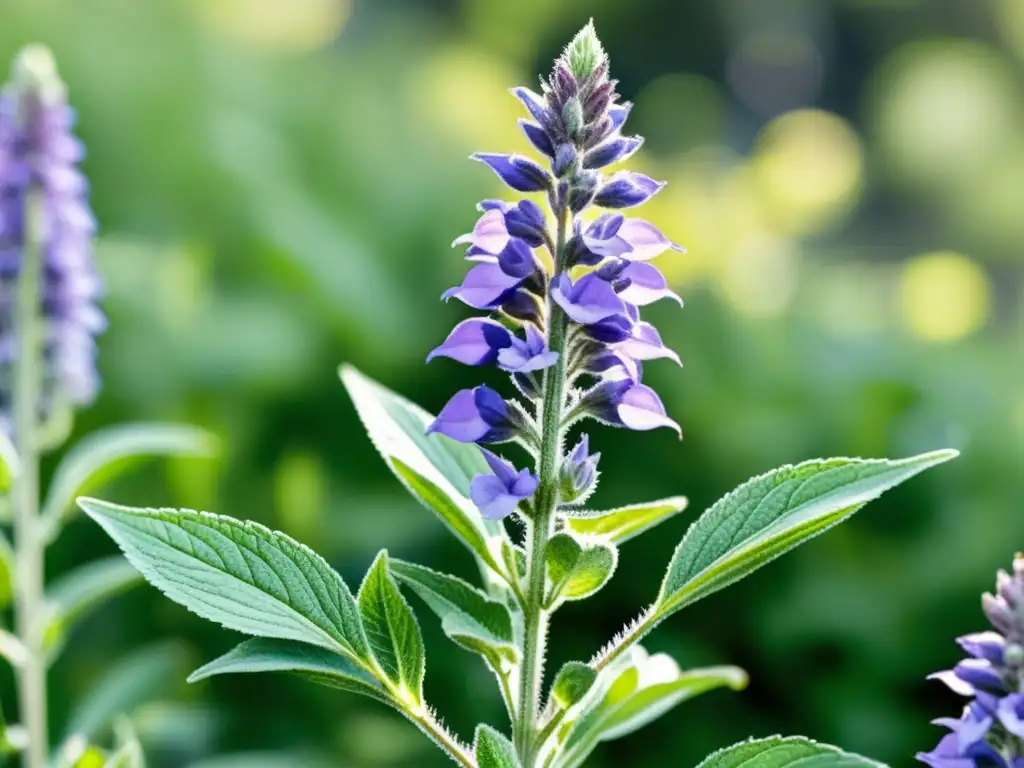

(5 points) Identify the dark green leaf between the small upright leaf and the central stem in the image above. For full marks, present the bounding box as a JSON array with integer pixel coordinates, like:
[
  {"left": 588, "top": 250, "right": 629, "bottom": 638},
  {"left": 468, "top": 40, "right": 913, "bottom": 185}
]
[{"left": 390, "top": 560, "right": 515, "bottom": 654}]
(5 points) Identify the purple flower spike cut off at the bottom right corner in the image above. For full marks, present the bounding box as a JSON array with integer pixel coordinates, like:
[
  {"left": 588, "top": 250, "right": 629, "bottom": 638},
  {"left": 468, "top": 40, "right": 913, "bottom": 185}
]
[{"left": 918, "top": 554, "right": 1024, "bottom": 768}]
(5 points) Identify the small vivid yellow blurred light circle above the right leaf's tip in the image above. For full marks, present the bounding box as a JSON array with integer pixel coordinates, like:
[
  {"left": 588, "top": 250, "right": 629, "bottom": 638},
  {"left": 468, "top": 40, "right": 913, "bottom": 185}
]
[{"left": 899, "top": 252, "right": 990, "bottom": 341}]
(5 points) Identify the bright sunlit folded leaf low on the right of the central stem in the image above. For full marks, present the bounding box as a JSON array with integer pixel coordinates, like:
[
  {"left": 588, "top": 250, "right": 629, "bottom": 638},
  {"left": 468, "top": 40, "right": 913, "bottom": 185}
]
[{"left": 556, "top": 646, "right": 745, "bottom": 768}]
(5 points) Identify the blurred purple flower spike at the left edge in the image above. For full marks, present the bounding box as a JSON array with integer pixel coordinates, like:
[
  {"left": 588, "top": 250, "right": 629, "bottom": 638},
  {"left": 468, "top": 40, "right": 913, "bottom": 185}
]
[{"left": 0, "top": 47, "right": 105, "bottom": 431}]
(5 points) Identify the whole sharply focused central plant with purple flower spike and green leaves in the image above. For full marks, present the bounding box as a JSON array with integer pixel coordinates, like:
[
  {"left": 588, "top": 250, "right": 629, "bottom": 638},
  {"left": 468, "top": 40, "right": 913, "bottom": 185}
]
[{"left": 12, "top": 25, "right": 955, "bottom": 768}]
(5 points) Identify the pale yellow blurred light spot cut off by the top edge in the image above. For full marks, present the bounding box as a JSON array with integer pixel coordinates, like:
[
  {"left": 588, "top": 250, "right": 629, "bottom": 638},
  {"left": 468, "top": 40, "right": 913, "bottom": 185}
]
[{"left": 191, "top": 0, "right": 352, "bottom": 53}]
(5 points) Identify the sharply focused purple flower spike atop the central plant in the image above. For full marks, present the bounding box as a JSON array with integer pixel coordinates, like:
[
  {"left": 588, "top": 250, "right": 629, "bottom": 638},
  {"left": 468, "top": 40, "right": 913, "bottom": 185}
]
[{"left": 427, "top": 25, "right": 682, "bottom": 518}]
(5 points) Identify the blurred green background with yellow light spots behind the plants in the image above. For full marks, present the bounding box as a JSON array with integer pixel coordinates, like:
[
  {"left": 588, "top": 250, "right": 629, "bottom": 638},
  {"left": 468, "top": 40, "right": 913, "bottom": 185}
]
[{"left": 0, "top": 0, "right": 1024, "bottom": 768}]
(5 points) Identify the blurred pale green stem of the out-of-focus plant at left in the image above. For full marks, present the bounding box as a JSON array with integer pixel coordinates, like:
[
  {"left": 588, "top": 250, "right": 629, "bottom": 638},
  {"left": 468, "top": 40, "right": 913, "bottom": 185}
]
[{"left": 12, "top": 191, "right": 48, "bottom": 768}]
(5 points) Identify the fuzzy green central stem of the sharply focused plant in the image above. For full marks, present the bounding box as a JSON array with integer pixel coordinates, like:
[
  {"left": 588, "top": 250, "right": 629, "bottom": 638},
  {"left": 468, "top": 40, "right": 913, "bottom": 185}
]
[{"left": 515, "top": 201, "right": 567, "bottom": 768}]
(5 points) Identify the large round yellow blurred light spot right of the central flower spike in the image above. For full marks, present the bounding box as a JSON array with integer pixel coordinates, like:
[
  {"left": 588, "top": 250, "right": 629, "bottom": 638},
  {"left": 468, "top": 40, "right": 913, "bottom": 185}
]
[{"left": 753, "top": 110, "right": 863, "bottom": 234}]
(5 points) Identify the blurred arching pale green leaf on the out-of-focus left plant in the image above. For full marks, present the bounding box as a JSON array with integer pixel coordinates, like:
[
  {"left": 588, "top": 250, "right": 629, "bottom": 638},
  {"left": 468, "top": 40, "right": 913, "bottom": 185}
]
[{"left": 42, "top": 423, "right": 217, "bottom": 539}]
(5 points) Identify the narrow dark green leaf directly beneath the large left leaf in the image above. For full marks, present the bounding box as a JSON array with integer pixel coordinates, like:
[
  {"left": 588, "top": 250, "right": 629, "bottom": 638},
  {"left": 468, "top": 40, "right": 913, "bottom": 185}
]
[{"left": 188, "top": 637, "right": 394, "bottom": 706}]
